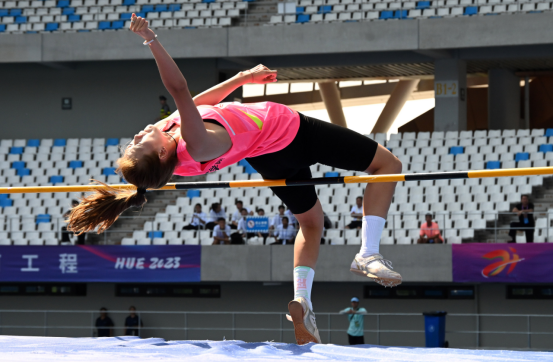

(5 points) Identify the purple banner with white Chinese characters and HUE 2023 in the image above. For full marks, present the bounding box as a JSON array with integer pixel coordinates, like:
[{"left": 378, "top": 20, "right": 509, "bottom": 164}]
[{"left": 0, "top": 246, "right": 201, "bottom": 282}]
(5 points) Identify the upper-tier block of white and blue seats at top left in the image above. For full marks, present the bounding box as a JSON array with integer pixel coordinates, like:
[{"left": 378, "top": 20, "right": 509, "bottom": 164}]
[{"left": 0, "top": 0, "right": 248, "bottom": 33}]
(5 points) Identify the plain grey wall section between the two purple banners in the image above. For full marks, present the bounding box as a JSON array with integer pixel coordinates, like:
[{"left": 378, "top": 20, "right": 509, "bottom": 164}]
[{"left": 202, "top": 245, "right": 453, "bottom": 282}]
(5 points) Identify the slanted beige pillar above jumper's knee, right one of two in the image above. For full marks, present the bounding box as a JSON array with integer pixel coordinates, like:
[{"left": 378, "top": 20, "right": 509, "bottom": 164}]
[{"left": 371, "top": 79, "right": 420, "bottom": 134}]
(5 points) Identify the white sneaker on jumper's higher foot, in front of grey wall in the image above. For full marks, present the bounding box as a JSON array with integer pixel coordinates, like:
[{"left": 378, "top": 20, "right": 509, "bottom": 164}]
[{"left": 350, "top": 254, "right": 402, "bottom": 287}]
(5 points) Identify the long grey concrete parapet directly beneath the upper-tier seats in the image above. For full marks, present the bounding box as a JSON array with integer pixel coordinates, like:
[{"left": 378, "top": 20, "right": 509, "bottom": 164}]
[{"left": 0, "top": 13, "right": 553, "bottom": 63}]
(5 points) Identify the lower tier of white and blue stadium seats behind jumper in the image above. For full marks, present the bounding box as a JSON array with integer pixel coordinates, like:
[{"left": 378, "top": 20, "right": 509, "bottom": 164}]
[{"left": 0, "top": 130, "right": 553, "bottom": 245}]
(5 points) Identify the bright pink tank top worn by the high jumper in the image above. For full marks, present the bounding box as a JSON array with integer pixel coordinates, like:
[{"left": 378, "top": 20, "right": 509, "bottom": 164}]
[{"left": 163, "top": 102, "right": 300, "bottom": 176}]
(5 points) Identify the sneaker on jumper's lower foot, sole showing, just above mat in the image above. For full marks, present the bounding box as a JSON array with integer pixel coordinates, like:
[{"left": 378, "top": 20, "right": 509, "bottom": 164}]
[{"left": 286, "top": 297, "right": 321, "bottom": 345}]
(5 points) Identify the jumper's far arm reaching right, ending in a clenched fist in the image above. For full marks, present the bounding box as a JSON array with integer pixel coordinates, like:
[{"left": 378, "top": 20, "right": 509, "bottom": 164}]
[{"left": 194, "top": 64, "right": 277, "bottom": 106}]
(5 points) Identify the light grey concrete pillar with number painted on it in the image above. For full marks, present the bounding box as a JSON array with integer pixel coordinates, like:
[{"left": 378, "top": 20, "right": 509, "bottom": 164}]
[{"left": 434, "top": 59, "right": 467, "bottom": 131}]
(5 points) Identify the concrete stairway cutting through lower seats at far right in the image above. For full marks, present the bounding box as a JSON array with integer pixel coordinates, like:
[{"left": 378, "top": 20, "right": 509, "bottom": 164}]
[{"left": 470, "top": 178, "right": 553, "bottom": 243}]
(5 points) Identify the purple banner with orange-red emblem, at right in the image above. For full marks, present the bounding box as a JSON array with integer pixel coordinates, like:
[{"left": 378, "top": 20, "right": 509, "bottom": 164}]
[{"left": 452, "top": 243, "right": 553, "bottom": 283}]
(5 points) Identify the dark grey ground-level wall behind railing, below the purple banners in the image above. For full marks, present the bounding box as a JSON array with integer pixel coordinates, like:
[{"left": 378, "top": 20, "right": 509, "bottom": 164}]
[{"left": 0, "top": 281, "right": 553, "bottom": 350}]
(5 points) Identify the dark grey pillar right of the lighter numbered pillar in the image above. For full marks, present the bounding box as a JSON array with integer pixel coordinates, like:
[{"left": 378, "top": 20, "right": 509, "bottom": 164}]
[{"left": 488, "top": 69, "right": 524, "bottom": 130}]
